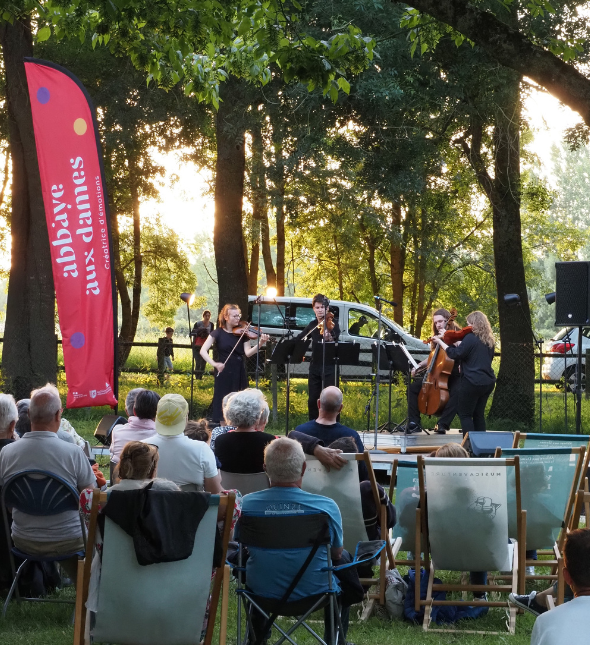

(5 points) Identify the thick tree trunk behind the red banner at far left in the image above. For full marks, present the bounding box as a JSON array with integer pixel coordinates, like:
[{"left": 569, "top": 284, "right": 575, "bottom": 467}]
[{"left": 0, "top": 19, "right": 57, "bottom": 399}]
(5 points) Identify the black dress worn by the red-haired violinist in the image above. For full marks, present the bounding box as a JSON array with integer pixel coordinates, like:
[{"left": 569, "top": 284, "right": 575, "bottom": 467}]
[{"left": 211, "top": 328, "right": 248, "bottom": 424}]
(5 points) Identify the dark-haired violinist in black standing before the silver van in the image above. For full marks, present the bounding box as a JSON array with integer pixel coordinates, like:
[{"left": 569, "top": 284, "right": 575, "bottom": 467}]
[{"left": 297, "top": 293, "right": 340, "bottom": 421}]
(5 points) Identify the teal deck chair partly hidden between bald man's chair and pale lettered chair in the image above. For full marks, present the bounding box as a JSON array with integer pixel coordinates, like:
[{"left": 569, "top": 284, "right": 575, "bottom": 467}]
[{"left": 389, "top": 461, "right": 420, "bottom": 567}]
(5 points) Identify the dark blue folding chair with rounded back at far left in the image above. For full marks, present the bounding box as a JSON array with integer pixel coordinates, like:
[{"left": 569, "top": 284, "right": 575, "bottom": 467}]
[{"left": 2, "top": 470, "right": 86, "bottom": 618}]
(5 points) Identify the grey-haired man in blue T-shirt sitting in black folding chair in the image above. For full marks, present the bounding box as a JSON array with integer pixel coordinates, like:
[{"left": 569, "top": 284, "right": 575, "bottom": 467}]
[{"left": 236, "top": 437, "right": 363, "bottom": 642}]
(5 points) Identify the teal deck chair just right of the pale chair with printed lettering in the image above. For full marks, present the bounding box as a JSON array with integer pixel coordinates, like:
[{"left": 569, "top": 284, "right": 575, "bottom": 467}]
[{"left": 496, "top": 446, "right": 586, "bottom": 603}]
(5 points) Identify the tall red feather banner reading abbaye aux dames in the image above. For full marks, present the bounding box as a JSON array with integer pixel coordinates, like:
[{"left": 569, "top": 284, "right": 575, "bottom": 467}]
[{"left": 25, "top": 58, "right": 117, "bottom": 408}]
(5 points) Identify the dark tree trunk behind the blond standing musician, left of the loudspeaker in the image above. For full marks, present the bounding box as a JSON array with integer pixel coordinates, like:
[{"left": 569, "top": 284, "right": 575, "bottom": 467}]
[{"left": 489, "top": 72, "right": 535, "bottom": 427}]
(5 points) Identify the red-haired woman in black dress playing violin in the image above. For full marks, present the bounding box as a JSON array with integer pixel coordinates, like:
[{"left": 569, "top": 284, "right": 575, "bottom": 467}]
[{"left": 200, "top": 304, "right": 268, "bottom": 423}]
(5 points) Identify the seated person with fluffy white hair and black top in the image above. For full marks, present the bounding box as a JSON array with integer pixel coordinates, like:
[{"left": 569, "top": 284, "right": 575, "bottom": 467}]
[{"left": 215, "top": 389, "right": 275, "bottom": 473}]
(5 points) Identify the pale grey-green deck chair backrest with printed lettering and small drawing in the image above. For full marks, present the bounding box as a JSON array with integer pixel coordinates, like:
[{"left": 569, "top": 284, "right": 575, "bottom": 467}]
[{"left": 418, "top": 458, "right": 517, "bottom": 571}]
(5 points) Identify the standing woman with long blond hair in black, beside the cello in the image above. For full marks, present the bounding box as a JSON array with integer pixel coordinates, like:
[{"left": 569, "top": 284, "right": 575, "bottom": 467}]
[{"left": 432, "top": 311, "right": 496, "bottom": 435}]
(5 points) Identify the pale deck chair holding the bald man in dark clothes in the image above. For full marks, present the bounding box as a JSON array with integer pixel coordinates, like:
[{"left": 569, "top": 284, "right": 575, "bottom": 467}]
[{"left": 301, "top": 450, "right": 395, "bottom": 605}]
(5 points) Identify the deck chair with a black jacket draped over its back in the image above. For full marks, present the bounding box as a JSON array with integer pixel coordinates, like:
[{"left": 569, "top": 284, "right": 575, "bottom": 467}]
[{"left": 74, "top": 490, "right": 235, "bottom": 645}]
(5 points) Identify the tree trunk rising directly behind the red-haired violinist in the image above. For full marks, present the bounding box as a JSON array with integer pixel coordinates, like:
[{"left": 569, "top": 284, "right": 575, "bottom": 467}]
[{"left": 213, "top": 78, "right": 248, "bottom": 313}]
